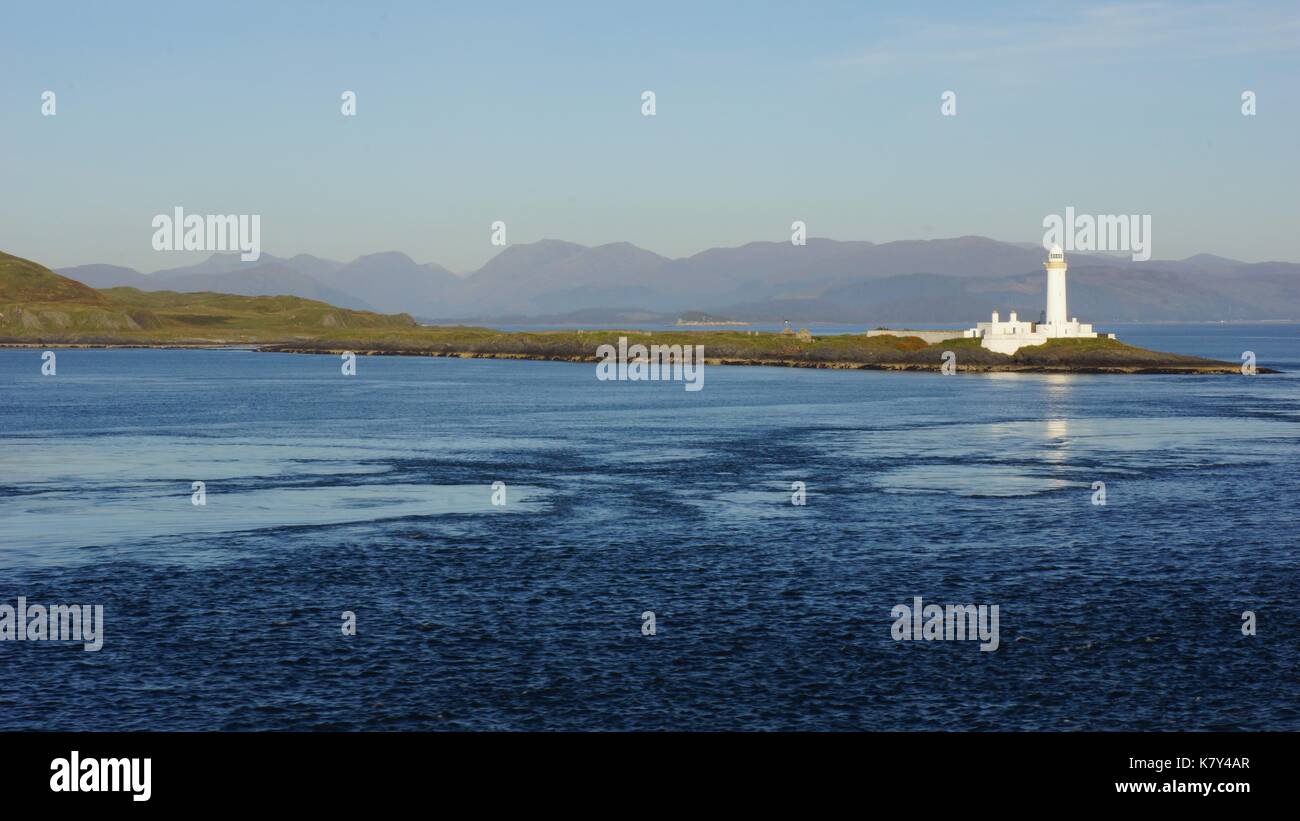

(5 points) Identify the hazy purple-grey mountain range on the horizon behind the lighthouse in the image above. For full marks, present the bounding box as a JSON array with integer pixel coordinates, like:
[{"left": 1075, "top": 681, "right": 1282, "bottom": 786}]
[{"left": 59, "top": 236, "right": 1300, "bottom": 325}]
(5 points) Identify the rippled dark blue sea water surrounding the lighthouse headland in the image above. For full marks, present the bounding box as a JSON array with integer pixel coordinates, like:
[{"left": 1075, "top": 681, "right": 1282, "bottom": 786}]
[{"left": 0, "top": 325, "right": 1300, "bottom": 730}]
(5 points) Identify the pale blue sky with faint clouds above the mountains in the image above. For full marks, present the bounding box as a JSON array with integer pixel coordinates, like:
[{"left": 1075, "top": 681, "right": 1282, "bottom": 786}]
[{"left": 0, "top": 0, "right": 1300, "bottom": 272}]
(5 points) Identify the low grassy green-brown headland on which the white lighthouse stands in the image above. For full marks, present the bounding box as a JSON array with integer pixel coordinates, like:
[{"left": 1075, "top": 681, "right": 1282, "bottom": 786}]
[{"left": 0, "top": 253, "right": 1271, "bottom": 373}]
